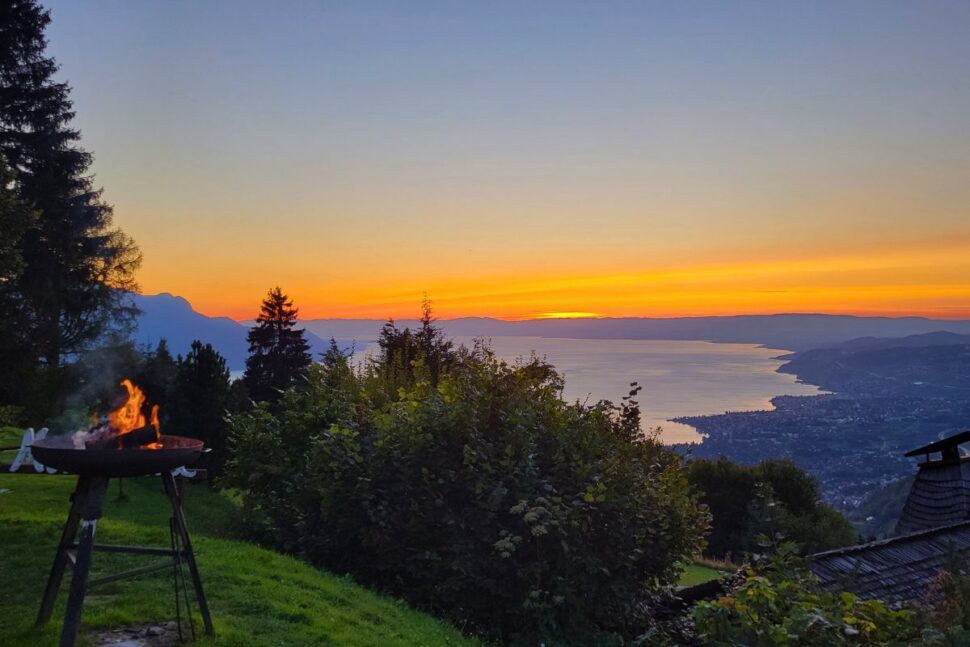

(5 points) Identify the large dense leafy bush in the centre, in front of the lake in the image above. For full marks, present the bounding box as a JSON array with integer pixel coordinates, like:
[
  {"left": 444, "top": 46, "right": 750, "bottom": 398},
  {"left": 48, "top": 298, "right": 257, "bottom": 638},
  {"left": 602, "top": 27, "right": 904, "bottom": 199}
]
[{"left": 228, "top": 342, "right": 706, "bottom": 644}]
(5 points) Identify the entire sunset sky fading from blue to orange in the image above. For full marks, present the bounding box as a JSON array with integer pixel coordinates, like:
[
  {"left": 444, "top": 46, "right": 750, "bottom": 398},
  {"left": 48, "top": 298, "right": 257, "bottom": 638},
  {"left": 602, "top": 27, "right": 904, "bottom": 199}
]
[{"left": 45, "top": 0, "right": 970, "bottom": 319}]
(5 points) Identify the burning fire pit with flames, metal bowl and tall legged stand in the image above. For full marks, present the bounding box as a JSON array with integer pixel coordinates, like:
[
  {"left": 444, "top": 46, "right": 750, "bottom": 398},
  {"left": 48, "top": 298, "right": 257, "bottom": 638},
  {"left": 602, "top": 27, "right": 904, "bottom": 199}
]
[{"left": 31, "top": 380, "right": 214, "bottom": 647}]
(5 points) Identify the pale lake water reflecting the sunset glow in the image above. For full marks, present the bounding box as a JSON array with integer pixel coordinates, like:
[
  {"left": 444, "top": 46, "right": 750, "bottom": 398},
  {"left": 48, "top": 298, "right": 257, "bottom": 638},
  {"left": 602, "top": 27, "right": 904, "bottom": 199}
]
[{"left": 362, "top": 337, "right": 821, "bottom": 443}]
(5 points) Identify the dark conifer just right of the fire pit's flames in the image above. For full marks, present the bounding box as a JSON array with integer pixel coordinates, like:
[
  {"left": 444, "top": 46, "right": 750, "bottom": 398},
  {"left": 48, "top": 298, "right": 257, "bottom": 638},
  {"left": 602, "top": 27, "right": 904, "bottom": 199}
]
[{"left": 170, "top": 340, "right": 229, "bottom": 478}]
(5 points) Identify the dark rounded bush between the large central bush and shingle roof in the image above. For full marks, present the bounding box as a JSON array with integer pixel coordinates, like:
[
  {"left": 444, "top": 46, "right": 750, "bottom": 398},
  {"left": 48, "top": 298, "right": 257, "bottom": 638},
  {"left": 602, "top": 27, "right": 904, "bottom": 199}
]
[{"left": 687, "top": 457, "right": 858, "bottom": 558}]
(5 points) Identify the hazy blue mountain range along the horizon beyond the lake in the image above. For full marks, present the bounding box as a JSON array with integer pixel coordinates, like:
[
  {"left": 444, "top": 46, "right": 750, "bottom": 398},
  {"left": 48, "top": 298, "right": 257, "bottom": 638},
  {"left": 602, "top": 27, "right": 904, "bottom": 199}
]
[{"left": 134, "top": 293, "right": 970, "bottom": 370}]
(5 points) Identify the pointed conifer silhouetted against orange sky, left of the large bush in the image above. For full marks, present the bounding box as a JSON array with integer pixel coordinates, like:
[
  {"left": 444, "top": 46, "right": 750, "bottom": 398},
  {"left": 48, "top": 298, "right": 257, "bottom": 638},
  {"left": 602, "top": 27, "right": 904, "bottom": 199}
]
[{"left": 243, "top": 287, "right": 312, "bottom": 402}]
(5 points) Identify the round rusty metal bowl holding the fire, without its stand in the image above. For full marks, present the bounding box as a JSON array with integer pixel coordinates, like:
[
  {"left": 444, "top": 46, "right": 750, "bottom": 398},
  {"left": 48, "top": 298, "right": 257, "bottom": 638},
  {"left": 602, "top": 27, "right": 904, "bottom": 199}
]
[{"left": 30, "top": 436, "right": 203, "bottom": 477}]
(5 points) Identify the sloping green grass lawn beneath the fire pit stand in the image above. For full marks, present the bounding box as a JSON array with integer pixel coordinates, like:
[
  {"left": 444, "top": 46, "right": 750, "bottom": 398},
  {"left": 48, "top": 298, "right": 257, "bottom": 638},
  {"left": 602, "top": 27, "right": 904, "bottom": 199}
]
[{"left": 0, "top": 474, "right": 477, "bottom": 646}]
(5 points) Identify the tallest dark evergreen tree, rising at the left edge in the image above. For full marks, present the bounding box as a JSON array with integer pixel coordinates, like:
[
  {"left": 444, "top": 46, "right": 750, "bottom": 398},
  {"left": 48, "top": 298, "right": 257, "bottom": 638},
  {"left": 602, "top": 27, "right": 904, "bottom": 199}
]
[{"left": 0, "top": 0, "right": 141, "bottom": 380}]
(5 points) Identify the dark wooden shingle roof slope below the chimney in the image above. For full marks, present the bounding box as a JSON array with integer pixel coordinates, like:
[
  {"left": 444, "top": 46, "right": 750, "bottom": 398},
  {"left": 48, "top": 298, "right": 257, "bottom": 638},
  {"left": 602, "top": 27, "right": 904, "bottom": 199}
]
[{"left": 809, "top": 521, "right": 970, "bottom": 603}]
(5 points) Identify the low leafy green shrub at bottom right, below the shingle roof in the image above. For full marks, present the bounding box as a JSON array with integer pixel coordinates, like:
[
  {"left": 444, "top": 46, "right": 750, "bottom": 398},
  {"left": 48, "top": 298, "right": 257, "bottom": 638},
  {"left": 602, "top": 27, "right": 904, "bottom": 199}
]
[{"left": 691, "top": 543, "right": 920, "bottom": 647}]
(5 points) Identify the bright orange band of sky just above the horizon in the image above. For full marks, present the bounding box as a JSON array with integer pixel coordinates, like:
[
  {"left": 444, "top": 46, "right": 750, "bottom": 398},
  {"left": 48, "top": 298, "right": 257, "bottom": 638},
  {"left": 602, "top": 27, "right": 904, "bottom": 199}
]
[{"left": 138, "top": 233, "right": 970, "bottom": 320}]
